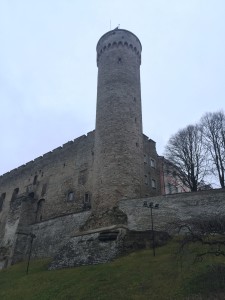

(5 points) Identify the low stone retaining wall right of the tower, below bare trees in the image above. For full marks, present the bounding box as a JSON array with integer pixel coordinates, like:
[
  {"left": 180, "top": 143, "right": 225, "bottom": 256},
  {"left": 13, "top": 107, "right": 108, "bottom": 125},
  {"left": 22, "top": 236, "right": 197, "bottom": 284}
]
[{"left": 119, "top": 189, "right": 225, "bottom": 233}]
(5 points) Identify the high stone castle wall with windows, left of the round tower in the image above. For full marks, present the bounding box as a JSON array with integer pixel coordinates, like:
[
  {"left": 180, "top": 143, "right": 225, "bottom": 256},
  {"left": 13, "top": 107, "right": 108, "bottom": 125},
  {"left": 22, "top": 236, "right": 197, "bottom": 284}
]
[{"left": 0, "top": 132, "right": 94, "bottom": 262}]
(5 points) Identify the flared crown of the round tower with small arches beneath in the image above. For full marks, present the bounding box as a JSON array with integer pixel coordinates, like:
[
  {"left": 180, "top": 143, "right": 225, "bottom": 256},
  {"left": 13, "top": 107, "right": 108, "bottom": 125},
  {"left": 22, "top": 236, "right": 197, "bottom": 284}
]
[{"left": 96, "top": 29, "right": 142, "bottom": 65}]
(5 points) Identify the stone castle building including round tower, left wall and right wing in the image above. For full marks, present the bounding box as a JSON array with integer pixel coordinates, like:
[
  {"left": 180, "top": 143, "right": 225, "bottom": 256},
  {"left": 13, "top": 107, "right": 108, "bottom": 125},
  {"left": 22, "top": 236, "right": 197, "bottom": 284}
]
[{"left": 0, "top": 29, "right": 162, "bottom": 267}]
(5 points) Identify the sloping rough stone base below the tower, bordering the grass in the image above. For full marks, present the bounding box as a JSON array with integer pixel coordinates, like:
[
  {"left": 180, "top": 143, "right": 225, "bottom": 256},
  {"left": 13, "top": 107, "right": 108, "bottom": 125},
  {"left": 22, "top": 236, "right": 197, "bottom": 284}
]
[{"left": 49, "top": 225, "right": 169, "bottom": 270}]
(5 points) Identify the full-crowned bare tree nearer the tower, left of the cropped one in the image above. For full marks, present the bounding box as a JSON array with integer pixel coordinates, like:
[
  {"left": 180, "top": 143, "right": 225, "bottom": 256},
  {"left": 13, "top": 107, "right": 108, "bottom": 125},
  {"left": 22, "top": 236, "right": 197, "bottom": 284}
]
[{"left": 165, "top": 125, "right": 207, "bottom": 191}]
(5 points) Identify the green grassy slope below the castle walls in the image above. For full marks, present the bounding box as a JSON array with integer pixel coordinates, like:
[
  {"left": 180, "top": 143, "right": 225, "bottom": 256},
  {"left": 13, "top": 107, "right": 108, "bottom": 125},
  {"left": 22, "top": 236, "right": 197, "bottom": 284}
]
[{"left": 0, "top": 242, "right": 225, "bottom": 300}]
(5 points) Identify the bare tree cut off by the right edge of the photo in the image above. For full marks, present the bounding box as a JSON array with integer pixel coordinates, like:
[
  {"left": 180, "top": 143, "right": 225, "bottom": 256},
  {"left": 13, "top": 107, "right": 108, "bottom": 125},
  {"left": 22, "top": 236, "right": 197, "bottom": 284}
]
[{"left": 201, "top": 111, "right": 225, "bottom": 188}]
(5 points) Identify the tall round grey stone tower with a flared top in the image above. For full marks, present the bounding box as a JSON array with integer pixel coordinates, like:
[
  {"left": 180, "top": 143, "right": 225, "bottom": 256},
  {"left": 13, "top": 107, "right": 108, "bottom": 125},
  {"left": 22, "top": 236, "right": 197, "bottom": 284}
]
[{"left": 92, "top": 29, "right": 144, "bottom": 211}]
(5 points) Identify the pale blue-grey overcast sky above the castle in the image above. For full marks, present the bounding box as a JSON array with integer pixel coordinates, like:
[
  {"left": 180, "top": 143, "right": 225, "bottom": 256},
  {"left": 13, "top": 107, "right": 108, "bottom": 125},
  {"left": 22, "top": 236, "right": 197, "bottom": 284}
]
[{"left": 0, "top": 0, "right": 225, "bottom": 174}]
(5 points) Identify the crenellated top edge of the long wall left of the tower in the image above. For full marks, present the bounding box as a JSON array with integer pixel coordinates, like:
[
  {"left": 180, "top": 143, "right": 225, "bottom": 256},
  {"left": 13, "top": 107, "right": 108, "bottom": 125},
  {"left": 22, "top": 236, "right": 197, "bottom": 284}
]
[{"left": 0, "top": 130, "right": 94, "bottom": 180}]
